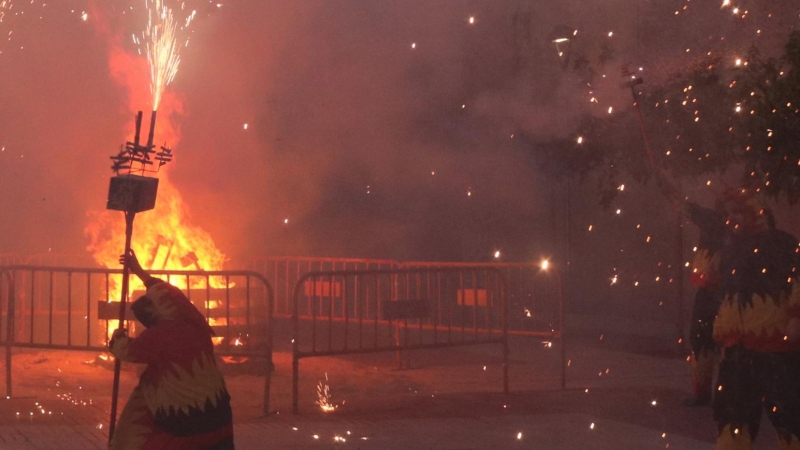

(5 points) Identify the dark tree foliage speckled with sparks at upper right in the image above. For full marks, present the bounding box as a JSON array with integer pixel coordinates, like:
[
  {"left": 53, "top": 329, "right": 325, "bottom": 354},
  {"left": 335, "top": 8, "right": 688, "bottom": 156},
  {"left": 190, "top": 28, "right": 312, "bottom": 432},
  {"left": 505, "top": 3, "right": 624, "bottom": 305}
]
[{"left": 520, "top": 32, "right": 800, "bottom": 205}]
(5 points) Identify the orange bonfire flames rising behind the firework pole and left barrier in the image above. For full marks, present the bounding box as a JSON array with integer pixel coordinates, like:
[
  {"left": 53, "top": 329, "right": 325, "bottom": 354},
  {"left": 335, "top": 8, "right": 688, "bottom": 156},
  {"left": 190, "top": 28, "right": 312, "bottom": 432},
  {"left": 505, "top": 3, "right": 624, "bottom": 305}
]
[{"left": 84, "top": 0, "right": 225, "bottom": 329}]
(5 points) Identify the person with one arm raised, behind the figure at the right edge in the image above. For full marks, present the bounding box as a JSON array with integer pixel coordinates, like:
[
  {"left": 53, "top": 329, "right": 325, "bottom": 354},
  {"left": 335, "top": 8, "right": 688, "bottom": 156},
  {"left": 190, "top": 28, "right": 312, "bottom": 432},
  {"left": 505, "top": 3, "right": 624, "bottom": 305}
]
[{"left": 658, "top": 176, "right": 727, "bottom": 406}]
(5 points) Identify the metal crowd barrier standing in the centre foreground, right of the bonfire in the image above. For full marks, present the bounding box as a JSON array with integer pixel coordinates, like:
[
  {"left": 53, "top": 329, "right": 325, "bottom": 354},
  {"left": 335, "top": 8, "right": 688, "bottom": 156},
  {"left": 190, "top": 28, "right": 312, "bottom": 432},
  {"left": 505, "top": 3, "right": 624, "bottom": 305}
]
[{"left": 292, "top": 267, "right": 508, "bottom": 414}]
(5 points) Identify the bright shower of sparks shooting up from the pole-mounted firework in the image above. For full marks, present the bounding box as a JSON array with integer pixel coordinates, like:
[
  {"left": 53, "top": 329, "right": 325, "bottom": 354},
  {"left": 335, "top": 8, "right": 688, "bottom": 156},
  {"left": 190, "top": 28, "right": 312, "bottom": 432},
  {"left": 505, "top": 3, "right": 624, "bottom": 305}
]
[{"left": 145, "top": 0, "right": 181, "bottom": 111}]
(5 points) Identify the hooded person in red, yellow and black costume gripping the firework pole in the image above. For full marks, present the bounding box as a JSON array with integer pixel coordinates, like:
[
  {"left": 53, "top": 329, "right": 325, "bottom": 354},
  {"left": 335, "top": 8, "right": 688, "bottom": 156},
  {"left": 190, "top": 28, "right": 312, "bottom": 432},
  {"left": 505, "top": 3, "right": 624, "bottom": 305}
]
[{"left": 109, "top": 251, "right": 234, "bottom": 450}]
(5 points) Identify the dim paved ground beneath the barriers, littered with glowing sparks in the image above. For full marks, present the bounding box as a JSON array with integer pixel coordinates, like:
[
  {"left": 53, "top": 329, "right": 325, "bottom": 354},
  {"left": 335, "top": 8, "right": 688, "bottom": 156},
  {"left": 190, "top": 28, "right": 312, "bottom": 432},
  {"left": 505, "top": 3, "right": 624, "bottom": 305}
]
[{"left": 0, "top": 328, "right": 775, "bottom": 450}]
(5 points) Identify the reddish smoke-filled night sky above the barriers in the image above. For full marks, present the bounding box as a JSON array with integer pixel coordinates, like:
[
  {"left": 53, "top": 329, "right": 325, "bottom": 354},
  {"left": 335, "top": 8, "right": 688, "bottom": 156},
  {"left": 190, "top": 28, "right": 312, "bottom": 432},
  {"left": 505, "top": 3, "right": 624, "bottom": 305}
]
[{"left": 0, "top": 0, "right": 800, "bottom": 316}]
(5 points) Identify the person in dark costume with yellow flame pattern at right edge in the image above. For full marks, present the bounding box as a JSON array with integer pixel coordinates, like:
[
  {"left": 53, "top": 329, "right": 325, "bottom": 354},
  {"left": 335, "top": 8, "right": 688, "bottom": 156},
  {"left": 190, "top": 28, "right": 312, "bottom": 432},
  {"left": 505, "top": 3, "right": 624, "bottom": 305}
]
[{"left": 713, "top": 193, "right": 800, "bottom": 450}]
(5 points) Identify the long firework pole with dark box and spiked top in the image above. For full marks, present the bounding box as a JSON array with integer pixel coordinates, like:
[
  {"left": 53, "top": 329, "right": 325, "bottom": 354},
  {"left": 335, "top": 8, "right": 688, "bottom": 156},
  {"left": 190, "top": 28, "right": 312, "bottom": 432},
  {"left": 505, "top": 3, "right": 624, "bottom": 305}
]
[{"left": 106, "top": 111, "right": 172, "bottom": 442}]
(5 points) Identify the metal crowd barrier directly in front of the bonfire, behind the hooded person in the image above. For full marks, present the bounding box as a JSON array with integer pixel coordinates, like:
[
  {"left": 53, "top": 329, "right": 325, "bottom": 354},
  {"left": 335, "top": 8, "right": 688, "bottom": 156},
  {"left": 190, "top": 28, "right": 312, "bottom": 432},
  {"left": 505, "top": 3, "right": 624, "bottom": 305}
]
[{"left": 0, "top": 266, "right": 274, "bottom": 412}]
